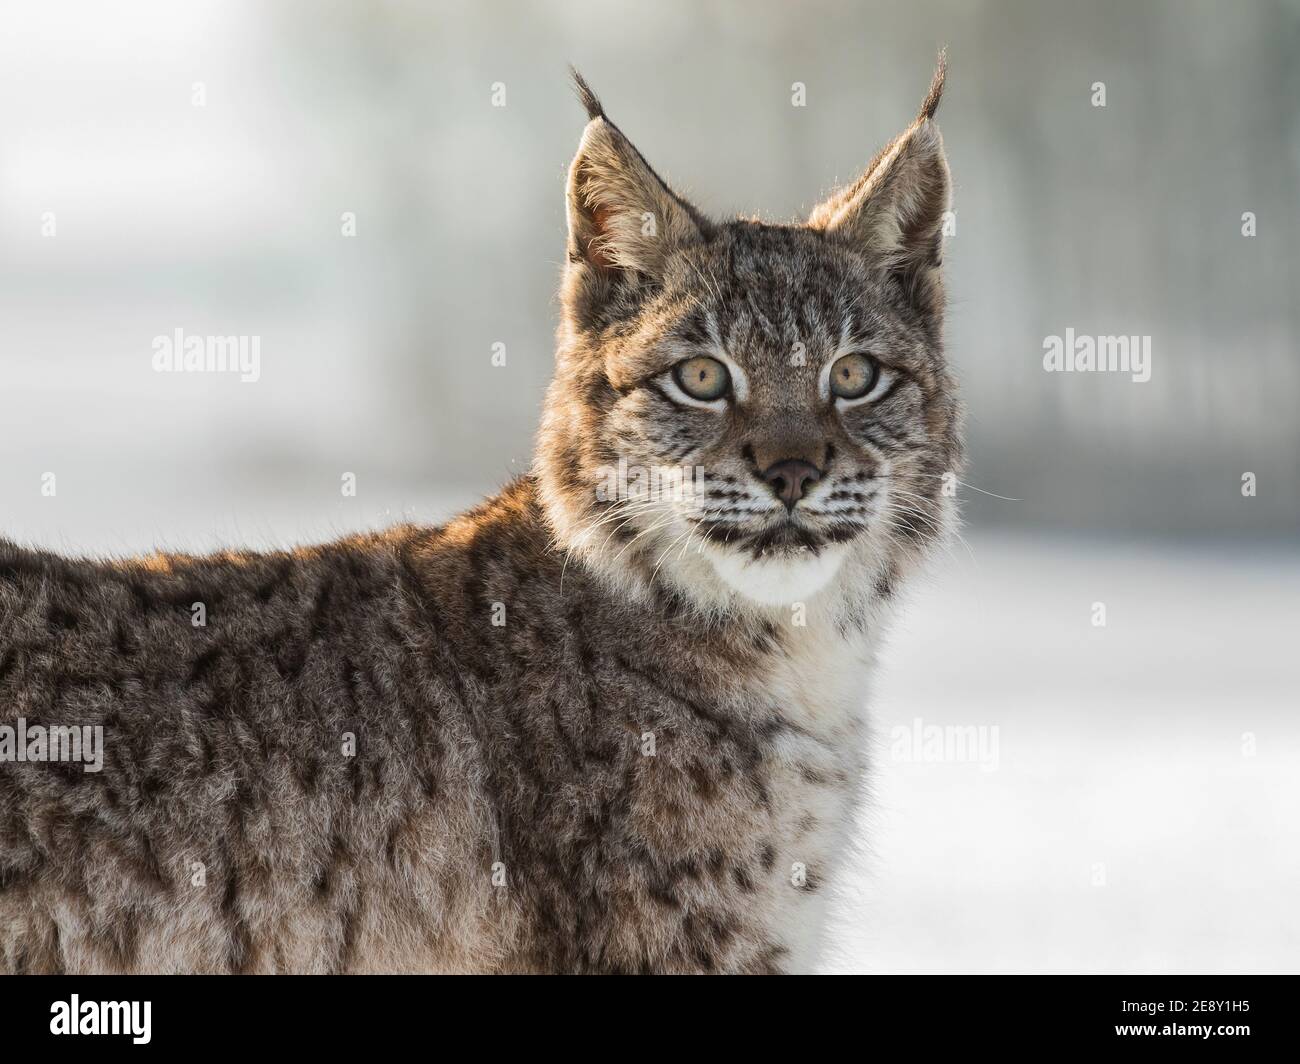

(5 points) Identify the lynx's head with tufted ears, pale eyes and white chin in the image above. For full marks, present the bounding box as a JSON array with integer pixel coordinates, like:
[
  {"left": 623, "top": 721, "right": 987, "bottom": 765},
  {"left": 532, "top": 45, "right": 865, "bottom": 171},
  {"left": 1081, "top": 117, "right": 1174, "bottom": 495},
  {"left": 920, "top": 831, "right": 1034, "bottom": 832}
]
[{"left": 538, "top": 59, "right": 961, "bottom": 609}]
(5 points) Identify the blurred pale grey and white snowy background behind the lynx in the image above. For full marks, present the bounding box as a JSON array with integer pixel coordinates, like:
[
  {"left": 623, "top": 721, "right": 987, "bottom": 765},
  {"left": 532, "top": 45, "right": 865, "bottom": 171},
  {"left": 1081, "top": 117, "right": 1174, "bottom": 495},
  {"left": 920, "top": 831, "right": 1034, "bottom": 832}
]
[{"left": 0, "top": 0, "right": 1300, "bottom": 970}]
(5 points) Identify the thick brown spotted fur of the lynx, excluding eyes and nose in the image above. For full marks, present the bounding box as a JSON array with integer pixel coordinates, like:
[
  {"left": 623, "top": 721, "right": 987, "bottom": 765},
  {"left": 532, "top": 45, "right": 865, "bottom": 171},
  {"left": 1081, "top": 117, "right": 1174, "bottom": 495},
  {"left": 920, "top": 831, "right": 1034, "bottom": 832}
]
[{"left": 0, "top": 57, "right": 961, "bottom": 973}]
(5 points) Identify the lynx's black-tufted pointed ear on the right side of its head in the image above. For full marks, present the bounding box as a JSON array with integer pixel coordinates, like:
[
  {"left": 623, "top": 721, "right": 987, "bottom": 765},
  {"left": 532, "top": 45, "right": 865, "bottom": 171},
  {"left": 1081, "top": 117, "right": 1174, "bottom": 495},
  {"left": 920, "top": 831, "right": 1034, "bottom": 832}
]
[{"left": 807, "top": 55, "right": 950, "bottom": 310}]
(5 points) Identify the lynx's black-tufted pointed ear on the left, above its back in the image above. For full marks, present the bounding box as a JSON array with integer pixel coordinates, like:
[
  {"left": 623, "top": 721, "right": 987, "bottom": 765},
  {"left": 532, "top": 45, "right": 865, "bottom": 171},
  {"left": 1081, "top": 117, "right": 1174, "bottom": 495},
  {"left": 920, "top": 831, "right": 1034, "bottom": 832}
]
[{"left": 568, "top": 70, "right": 706, "bottom": 282}]
